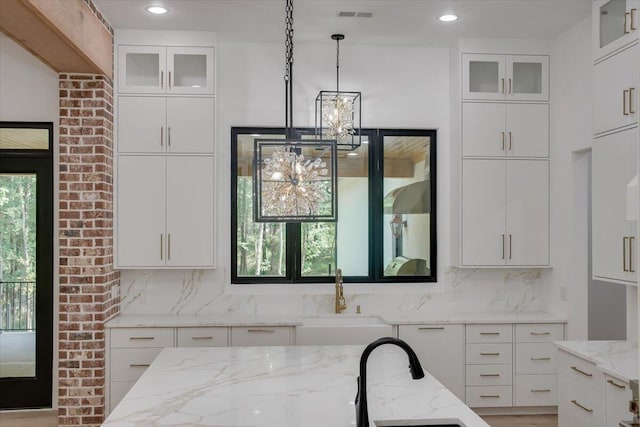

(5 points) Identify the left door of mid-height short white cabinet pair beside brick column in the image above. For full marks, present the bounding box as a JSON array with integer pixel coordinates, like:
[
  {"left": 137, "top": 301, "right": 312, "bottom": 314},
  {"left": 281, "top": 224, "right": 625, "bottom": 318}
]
[{"left": 118, "top": 96, "right": 167, "bottom": 153}]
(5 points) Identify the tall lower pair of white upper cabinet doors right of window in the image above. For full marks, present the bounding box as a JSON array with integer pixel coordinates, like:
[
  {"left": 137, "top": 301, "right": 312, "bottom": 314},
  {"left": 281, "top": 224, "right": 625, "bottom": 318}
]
[{"left": 462, "top": 159, "right": 549, "bottom": 266}]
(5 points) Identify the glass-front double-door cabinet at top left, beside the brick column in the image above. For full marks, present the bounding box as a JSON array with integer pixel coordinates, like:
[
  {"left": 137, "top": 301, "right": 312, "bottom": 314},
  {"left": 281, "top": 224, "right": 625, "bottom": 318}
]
[{"left": 118, "top": 45, "right": 214, "bottom": 95}]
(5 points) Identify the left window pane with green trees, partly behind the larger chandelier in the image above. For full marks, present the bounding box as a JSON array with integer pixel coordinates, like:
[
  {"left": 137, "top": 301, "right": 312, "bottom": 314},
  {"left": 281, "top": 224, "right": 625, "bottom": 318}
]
[{"left": 236, "top": 135, "right": 286, "bottom": 277}]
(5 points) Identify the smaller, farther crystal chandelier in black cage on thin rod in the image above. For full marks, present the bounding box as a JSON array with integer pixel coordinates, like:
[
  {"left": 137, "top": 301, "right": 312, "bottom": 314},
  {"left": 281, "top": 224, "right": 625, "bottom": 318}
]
[{"left": 315, "top": 34, "right": 361, "bottom": 151}]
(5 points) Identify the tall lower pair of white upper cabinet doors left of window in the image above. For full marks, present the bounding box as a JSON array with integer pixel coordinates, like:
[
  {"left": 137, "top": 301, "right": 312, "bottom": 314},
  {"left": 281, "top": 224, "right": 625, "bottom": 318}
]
[{"left": 117, "top": 155, "right": 214, "bottom": 268}]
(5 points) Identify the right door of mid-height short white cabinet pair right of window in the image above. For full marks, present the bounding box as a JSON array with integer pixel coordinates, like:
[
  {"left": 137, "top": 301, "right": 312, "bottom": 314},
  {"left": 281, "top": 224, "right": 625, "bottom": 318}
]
[{"left": 505, "top": 104, "right": 549, "bottom": 157}]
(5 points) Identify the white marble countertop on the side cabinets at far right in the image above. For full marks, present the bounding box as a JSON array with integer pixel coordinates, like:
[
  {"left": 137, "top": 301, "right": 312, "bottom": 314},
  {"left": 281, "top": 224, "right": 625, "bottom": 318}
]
[{"left": 555, "top": 341, "right": 639, "bottom": 381}]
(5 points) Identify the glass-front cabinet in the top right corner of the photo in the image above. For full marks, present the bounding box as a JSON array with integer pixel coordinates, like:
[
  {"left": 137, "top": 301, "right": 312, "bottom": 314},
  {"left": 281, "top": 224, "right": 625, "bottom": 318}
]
[{"left": 592, "top": 0, "right": 640, "bottom": 60}]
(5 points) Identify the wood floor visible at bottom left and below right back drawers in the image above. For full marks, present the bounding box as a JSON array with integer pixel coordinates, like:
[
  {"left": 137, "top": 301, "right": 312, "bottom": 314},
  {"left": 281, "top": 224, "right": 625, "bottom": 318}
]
[{"left": 0, "top": 411, "right": 558, "bottom": 427}]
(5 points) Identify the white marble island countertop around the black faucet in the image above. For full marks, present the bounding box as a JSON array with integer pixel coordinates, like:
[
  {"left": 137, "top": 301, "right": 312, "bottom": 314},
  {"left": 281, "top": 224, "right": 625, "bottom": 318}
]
[{"left": 103, "top": 345, "right": 489, "bottom": 427}]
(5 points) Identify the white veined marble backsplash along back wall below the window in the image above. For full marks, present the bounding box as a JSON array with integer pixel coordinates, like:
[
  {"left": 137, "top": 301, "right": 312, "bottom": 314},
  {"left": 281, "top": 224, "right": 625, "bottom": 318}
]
[{"left": 120, "top": 268, "right": 551, "bottom": 316}]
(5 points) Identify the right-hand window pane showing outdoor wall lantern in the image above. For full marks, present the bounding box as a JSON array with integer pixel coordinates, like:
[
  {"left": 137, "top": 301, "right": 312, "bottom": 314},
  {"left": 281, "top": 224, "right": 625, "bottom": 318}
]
[{"left": 383, "top": 136, "right": 431, "bottom": 276}]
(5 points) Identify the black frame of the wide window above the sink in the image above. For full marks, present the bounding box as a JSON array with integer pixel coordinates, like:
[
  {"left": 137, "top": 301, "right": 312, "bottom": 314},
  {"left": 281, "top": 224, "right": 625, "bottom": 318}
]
[{"left": 230, "top": 127, "right": 438, "bottom": 285}]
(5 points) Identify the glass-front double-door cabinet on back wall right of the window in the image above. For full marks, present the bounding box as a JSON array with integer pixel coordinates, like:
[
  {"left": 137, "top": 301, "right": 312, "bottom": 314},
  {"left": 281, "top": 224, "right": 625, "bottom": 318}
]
[{"left": 462, "top": 54, "right": 549, "bottom": 101}]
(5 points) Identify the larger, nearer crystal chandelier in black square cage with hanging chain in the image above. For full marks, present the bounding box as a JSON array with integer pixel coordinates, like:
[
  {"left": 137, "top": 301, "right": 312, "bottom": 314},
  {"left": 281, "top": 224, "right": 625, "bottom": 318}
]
[{"left": 253, "top": 0, "right": 338, "bottom": 222}]
